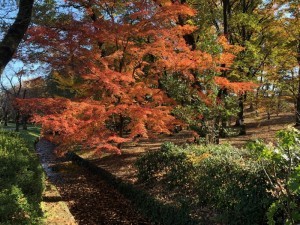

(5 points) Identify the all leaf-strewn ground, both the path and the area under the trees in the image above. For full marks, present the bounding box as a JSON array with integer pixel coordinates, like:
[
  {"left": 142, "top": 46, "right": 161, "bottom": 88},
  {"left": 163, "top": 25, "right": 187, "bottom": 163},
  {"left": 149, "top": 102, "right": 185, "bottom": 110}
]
[{"left": 2, "top": 109, "right": 294, "bottom": 225}]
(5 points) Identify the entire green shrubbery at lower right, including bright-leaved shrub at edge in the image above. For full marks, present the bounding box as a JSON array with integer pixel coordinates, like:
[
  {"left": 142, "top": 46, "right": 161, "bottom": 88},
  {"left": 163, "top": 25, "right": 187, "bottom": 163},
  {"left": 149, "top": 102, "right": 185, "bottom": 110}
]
[{"left": 136, "top": 127, "right": 299, "bottom": 224}]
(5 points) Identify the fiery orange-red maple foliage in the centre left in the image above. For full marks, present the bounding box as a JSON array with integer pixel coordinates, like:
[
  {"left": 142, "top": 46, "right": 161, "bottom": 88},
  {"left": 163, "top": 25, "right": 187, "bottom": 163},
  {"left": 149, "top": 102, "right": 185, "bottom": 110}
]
[{"left": 17, "top": 0, "right": 253, "bottom": 155}]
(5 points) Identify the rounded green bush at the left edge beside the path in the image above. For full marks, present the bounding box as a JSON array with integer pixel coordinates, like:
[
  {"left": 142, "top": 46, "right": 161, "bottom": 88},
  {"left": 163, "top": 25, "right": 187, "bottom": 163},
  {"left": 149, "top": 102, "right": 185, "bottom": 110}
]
[{"left": 0, "top": 131, "right": 44, "bottom": 224}]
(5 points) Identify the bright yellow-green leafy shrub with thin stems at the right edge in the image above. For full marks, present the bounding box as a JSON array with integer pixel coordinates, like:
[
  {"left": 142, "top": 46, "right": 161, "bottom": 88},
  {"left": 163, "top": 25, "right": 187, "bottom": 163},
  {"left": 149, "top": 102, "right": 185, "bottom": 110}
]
[{"left": 248, "top": 128, "right": 300, "bottom": 225}]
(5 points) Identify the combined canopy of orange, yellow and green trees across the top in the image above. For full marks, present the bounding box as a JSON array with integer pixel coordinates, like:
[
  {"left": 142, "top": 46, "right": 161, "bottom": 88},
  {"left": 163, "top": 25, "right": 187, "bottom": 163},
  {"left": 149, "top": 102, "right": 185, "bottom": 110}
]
[{"left": 1, "top": 0, "right": 300, "bottom": 152}]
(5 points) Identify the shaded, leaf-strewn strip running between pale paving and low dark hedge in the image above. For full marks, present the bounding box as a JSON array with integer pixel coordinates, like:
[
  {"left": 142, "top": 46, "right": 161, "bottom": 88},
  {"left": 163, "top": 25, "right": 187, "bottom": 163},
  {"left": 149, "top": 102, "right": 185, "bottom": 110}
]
[{"left": 37, "top": 140, "right": 151, "bottom": 225}]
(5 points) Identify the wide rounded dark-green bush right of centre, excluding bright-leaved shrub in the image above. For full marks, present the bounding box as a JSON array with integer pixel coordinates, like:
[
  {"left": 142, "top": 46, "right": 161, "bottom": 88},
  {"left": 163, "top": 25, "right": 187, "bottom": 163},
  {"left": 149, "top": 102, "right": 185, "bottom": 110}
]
[{"left": 136, "top": 143, "right": 273, "bottom": 225}]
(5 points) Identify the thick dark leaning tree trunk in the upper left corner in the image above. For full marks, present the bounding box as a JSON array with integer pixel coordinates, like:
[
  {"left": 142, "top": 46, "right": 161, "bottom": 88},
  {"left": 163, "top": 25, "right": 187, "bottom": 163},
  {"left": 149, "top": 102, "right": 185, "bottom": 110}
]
[{"left": 0, "top": 0, "right": 34, "bottom": 75}]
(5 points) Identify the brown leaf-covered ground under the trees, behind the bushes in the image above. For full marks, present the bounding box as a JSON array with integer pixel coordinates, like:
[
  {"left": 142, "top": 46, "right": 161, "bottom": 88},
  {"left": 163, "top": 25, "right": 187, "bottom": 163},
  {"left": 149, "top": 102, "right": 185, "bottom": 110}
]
[{"left": 80, "top": 112, "right": 295, "bottom": 183}]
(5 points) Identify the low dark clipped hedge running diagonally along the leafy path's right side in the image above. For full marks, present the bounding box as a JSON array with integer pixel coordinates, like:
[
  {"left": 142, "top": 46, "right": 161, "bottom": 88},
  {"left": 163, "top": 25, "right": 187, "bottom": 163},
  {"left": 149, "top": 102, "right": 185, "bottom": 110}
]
[{"left": 66, "top": 152, "right": 199, "bottom": 225}]
